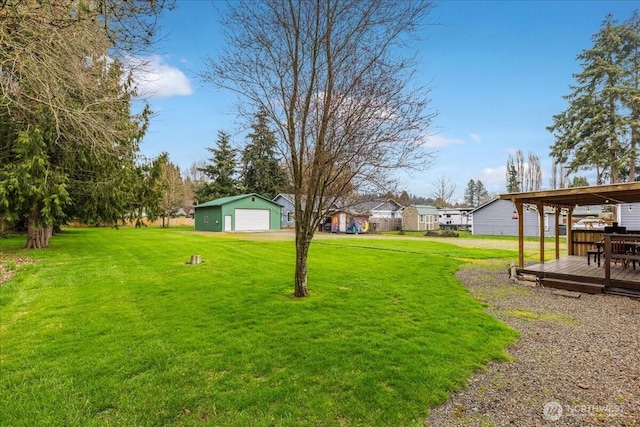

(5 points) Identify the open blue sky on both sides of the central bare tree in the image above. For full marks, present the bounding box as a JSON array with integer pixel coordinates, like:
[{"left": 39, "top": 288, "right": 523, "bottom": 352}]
[{"left": 135, "top": 0, "right": 640, "bottom": 199}]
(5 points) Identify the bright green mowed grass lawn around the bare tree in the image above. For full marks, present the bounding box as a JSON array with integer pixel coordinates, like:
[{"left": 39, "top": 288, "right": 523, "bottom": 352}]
[{"left": 0, "top": 228, "right": 517, "bottom": 426}]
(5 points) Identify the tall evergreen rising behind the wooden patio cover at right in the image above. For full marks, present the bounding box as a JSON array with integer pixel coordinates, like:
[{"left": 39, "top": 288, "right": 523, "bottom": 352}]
[{"left": 548, "top": 15, "right": 640, "bottom": 183}]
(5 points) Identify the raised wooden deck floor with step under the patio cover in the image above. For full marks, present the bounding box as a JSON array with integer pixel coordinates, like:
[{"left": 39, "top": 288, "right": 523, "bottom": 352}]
[{"left": 518, "top": 256, "right": 640, "bottom": 298}]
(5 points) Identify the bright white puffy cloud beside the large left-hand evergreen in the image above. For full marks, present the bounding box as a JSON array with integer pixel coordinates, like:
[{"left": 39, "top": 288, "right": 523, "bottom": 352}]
[{"left": 128, "top": 55, "right": 193, "bottom": 98}]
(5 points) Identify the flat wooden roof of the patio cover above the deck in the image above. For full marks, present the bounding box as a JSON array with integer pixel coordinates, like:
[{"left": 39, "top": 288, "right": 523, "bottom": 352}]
[{"left": 500, "top": 182, "right": 640, "bottom": 208}]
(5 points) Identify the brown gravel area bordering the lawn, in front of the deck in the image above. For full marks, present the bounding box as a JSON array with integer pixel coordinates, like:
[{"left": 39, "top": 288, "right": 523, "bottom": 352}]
[{"left": 426, "top": 265, "right": 640, "bottom": 427}]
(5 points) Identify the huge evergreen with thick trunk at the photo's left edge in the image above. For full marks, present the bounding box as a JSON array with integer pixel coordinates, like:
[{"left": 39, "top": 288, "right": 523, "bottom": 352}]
[{"left": 0, "top": 0, "right": 166, "bottom": 248}]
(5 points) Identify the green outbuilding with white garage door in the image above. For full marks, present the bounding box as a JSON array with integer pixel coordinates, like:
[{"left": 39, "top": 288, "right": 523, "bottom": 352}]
[{"left": 195, "top": 193, "right": 282, "bottom": 231}]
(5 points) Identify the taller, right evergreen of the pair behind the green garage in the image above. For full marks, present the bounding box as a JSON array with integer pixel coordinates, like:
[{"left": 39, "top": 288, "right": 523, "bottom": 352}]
[{"left": 242, "top": 110, "right": 287, "bottom": 199}]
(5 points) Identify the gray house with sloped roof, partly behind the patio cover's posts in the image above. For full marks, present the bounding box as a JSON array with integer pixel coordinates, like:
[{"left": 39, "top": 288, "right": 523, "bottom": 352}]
[{"left": 470, "top": 199, "right": 555, "bottom": 237}]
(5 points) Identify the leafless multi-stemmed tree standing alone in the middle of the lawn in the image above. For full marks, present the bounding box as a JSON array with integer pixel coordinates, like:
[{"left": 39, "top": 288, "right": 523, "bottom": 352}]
[{"left": 208, "top": 0, "right": 434, "bottom": 297}]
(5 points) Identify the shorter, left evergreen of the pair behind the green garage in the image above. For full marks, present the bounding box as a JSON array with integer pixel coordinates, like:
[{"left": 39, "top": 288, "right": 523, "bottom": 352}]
[{"left": 195, "top": 131, "right": 239, "bottom": 203}]
